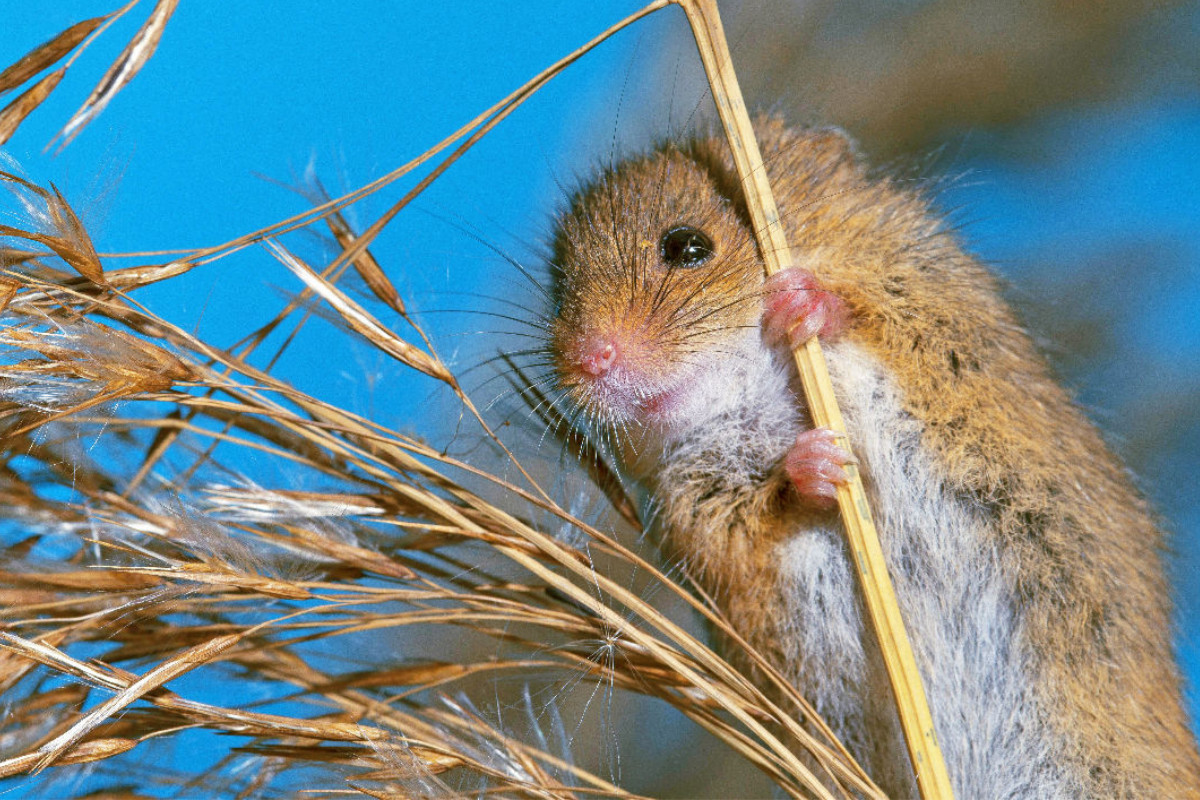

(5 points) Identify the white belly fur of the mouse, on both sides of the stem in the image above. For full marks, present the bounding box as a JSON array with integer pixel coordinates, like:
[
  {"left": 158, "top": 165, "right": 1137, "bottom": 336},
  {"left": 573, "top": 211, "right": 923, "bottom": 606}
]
[{"left": 779, "top": 342, "right": 1081, "bottom": 800}]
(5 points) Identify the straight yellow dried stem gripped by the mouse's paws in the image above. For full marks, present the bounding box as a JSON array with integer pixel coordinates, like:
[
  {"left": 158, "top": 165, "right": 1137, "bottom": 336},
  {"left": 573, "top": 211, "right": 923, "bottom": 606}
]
[{"left": 676, "top": 0, "right": 953, "bottom": 800}]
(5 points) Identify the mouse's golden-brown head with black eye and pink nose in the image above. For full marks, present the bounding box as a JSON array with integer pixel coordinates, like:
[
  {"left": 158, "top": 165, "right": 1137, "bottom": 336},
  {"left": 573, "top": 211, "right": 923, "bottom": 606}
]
[{"left": 550, "top": 146, "right": 763, "bottom": 425}]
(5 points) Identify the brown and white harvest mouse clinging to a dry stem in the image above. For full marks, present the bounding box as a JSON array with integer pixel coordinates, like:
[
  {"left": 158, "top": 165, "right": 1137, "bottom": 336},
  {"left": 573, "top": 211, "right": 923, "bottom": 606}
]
[{"left": 547, "top": 119, "right": 1200, "bottom": 800}]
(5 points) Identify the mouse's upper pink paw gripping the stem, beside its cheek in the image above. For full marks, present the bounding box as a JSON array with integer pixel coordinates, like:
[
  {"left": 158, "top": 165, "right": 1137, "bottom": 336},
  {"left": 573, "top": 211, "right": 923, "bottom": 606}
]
[{"left": 762, "top": 266, "right": 850, "bottom": 348}]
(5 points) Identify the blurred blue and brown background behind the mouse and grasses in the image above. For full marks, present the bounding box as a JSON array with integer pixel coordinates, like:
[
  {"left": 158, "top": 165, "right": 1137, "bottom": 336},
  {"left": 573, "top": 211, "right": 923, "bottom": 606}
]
[{"left": 7, "top": 0, "right": 1200, "bottom": 796}]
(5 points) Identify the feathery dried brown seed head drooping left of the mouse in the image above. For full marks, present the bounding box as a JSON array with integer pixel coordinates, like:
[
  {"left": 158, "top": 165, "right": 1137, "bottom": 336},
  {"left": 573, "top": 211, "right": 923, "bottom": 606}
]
[{"left": 0, "top": 2, "right": 880, "bottom": 798}]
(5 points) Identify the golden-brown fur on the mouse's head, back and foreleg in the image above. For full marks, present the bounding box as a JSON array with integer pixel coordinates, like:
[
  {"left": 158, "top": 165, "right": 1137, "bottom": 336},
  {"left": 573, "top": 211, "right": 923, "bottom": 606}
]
[{"left": 552, "top": 120, "right": 1200, "bottom": 798}]
